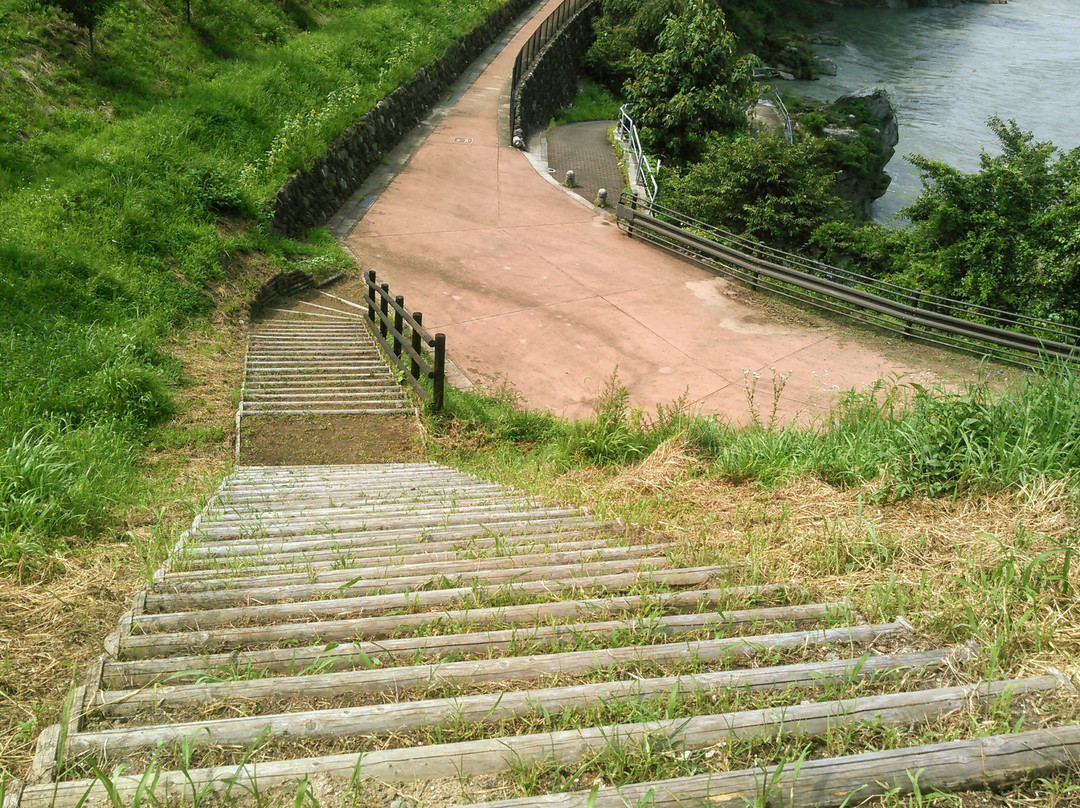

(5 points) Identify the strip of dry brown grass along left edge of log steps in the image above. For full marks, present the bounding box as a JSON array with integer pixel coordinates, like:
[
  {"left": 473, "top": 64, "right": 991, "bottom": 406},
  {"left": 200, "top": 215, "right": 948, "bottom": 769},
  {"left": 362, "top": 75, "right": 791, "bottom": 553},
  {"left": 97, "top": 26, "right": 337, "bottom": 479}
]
[{"left": 0, "top": 278, "right": 244, "bottom": 777}]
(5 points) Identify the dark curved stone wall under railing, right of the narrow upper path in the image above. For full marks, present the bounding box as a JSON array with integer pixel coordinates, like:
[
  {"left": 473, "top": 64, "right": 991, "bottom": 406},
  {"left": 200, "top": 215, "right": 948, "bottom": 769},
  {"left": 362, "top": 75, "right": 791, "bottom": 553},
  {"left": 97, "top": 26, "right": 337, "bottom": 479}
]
[{"left": 512, "top": 2, "right": 600, "bottom": 138}]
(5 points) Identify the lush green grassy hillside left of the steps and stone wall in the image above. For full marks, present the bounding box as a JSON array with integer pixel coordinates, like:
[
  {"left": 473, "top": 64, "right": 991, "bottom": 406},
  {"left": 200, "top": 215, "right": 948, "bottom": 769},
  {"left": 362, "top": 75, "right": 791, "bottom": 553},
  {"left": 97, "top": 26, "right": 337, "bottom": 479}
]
[{"left": 0, "top": 0, "right": 499, "bottom": 567}]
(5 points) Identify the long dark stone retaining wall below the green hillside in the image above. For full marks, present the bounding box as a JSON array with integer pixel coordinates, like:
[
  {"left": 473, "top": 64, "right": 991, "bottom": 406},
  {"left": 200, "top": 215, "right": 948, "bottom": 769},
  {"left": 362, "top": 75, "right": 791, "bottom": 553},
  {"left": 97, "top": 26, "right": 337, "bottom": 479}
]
[{"left": 271, "top": 0, "right": 533, "bottom": 237}]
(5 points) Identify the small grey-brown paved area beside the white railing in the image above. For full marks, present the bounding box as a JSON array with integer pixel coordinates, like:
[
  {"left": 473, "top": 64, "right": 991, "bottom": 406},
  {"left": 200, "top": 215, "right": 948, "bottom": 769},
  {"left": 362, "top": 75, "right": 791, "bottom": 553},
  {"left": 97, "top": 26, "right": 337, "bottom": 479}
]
[{"left": 546, "top": 121, "right": 626, "bottom": 206}]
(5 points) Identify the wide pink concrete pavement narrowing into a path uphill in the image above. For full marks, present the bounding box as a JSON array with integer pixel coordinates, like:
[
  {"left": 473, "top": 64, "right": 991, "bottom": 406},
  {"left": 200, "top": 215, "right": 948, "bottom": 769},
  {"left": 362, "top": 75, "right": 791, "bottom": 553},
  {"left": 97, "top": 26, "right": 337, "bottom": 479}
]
[{"left": 346, "top": 0, "right": 954, "bottom": 421}]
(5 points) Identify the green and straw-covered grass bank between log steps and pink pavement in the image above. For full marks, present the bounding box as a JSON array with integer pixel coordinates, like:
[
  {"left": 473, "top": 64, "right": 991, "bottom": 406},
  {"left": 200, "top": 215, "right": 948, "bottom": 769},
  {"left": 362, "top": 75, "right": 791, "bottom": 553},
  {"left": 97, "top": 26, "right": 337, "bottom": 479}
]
[{"left": 434, "top": 368, "right": 1080, "bottom": 699}]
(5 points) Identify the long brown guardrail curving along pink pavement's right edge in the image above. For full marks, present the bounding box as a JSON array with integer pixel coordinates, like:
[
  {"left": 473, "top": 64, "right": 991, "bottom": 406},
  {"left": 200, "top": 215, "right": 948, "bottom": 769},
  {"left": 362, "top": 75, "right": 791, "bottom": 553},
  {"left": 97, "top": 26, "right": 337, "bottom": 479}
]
[{"left": 616, "top": 193, "right": 1080, "bottom": 368}]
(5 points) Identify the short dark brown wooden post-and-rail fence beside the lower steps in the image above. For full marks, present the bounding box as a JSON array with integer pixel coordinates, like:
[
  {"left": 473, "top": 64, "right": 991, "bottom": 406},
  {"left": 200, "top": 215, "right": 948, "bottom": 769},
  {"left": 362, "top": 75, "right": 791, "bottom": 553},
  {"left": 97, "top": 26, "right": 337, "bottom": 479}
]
[{"left": 364, "top": 270, "right": 446, "bottom": 412}]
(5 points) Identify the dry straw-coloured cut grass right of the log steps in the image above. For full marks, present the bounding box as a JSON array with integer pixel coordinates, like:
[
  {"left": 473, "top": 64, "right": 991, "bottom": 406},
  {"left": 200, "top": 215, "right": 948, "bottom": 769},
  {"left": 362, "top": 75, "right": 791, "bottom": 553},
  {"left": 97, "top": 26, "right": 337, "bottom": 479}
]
[{"left": 559, "top": 451, "right": 1080, "bottom": 678}]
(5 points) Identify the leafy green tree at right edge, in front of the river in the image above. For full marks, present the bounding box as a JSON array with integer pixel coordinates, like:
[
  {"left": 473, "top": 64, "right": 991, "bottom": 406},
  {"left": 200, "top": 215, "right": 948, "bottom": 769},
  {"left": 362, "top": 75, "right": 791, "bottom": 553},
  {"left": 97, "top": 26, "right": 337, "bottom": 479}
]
[{"left": 903, "top": 118, "right": 1080, "bottom": 324}]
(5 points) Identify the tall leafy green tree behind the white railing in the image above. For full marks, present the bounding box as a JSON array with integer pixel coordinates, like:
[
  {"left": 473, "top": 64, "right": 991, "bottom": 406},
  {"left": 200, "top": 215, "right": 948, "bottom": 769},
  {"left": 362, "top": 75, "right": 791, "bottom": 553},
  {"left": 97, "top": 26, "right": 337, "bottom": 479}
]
[{"left": 624, "top": 0, "right": 758, "bottom": 163}]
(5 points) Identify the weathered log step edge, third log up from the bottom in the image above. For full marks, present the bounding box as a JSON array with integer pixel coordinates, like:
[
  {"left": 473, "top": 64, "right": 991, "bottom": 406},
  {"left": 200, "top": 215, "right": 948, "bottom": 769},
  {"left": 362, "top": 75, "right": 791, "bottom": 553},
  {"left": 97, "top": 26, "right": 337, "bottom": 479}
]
[{"left": 68, "top": 648, "right": 966, "bottom": 756}]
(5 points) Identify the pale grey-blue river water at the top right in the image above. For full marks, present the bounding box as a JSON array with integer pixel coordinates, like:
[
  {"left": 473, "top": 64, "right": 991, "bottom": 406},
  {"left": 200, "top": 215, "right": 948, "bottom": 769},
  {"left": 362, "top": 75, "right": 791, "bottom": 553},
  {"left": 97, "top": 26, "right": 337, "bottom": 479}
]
[{"left": 780, "top": 0, "right": 1080, "bottom": 221}]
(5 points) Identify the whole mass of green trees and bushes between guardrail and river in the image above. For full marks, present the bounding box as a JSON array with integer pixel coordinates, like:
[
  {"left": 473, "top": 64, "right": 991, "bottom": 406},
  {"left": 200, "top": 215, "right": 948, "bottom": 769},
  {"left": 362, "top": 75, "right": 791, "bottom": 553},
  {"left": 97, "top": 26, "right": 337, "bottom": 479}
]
[{"left": 589, "top": 0, "right": 1080, "bottom": 325}]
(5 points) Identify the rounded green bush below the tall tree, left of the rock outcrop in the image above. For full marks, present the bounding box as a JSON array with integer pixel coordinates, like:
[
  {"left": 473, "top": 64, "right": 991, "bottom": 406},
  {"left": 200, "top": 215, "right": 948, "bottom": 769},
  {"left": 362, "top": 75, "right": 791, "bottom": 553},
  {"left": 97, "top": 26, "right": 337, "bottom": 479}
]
[{"left": 661, "top": 135, "right": 843, "bottom": 251}]
